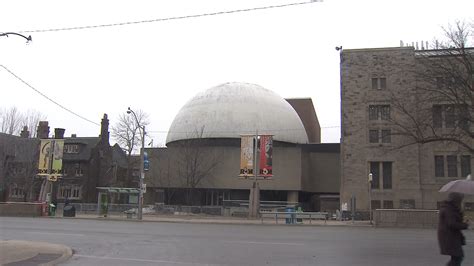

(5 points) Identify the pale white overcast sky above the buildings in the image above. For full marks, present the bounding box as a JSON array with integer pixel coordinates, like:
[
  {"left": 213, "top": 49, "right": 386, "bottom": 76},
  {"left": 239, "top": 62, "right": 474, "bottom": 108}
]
[{"left": 0, "top": 0, "right": 474, "bottom": 146}]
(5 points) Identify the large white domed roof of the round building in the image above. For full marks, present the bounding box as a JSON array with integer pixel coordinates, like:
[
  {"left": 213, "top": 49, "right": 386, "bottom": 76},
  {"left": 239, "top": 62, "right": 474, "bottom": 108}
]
[{"left": 166, "top": 82, "right": 308, "bottom": 144}]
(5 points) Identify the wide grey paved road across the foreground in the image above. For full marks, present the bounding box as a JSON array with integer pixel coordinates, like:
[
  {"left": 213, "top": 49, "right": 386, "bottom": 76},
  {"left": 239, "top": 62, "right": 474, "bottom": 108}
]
[{"left": 0, "top": 217, "right": 474, "bottom": 266}]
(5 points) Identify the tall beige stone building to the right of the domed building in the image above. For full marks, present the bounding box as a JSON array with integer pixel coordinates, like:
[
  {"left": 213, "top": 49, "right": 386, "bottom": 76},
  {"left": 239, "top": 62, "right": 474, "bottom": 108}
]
[{"left": 340, "top": 47, "right": 473, "bottom": 210}]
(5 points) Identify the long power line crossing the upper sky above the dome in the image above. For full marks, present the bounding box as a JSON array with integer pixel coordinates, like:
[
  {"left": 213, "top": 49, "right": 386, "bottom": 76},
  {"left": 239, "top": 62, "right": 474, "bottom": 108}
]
[{"left": 19, "top": 0, "right": 322, "bottom": 33}]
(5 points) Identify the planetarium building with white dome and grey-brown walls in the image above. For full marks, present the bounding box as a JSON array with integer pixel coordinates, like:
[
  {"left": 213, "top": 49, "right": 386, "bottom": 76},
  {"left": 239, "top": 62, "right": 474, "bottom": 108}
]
[{"left": 145, "top": 82, "right": 340, "bottom": 211}]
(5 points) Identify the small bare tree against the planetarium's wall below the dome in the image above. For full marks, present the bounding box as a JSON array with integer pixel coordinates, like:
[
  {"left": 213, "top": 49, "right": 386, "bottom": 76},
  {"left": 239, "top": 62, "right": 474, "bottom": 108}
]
[{"left": 170, "top": 127, "right": 220, "bottom": 205}]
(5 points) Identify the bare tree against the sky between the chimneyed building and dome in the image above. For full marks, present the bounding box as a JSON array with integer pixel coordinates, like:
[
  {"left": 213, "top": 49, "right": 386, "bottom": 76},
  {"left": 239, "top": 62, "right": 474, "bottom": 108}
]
[{"left": 112, "top": 110, "right": 149, "bottom": 186}]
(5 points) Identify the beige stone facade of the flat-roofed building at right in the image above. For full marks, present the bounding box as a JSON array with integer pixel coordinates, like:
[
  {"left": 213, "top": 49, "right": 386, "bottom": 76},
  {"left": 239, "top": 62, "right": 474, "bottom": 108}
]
[{"left": 340, "top": 47, "right": 473, "bottom": 210}]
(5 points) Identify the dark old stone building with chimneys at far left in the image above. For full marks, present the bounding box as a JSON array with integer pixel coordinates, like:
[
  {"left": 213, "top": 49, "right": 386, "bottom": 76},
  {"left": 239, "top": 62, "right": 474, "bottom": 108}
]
[{"left": 0, "top": 114, "right": 132, "bottom": 203}]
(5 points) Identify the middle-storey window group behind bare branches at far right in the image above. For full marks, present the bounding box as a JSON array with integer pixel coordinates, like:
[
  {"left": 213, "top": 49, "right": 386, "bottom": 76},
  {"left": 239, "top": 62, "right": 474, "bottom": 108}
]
[{"left": 432, "top": 104, "right": 470, "bottom": 130}]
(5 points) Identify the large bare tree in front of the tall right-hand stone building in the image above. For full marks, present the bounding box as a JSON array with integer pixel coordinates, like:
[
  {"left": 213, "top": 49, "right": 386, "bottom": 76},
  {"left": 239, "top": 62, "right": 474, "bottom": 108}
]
[{"left": 390, "top": 22, "right": 474, "bottom": 153}]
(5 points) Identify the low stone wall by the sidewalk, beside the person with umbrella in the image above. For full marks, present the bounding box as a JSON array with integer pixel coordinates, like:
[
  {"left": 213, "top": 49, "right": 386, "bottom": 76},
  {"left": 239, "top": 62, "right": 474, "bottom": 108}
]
[{"left": 373, "top": 209, "right": 438, "bottom": 228}]
